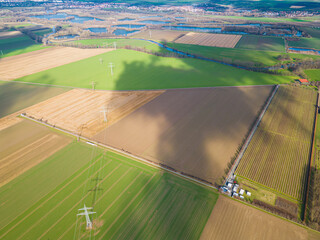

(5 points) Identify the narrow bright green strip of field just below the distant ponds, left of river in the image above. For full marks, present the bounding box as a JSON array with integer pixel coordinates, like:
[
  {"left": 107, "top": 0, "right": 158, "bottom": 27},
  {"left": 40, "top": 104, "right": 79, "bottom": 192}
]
[{"left": 70, "top": 38, "right": 163, "bottom": 52}]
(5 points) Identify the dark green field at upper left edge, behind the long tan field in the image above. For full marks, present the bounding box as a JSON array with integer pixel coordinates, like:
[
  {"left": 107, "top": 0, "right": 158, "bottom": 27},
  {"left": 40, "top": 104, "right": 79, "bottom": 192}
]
[{"left": 0, "top": 35, "right": 47, "bottom": 58}]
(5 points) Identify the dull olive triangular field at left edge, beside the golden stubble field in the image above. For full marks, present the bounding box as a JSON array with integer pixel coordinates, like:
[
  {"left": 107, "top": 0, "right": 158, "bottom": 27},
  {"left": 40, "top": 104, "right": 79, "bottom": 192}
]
[{"left": 0, "top": 81, "right": 70, "bottom": 118}]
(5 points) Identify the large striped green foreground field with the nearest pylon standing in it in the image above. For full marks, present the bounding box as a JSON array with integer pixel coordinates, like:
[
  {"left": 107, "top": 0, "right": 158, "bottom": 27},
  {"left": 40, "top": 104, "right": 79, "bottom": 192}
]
[{"left": 0, "top": 142, "right": 218, "bottom": 240}]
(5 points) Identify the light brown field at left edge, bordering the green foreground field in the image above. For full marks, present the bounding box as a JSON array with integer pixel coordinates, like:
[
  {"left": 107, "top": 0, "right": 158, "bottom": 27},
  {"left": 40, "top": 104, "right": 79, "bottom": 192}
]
[{"left": 0, "top": 120, "right": 72, "bottom": 187}]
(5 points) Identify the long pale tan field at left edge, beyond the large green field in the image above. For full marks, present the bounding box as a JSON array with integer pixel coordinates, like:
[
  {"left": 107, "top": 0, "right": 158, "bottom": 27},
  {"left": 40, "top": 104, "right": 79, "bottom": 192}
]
[{"left": 0, "top": 47, "right": 112, "bottom": 80}]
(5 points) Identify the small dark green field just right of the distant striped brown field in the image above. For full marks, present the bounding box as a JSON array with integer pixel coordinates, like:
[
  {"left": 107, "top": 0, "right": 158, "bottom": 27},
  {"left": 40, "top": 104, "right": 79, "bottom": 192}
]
[{"left": 236, "top": 35, "right": 285, "bottom": 53}]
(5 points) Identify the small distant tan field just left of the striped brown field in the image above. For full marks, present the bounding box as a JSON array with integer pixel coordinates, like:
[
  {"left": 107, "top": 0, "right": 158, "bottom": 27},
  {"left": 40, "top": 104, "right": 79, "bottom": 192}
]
[{"left": 131, "top": 30, "right": 187, "bottom": 42}]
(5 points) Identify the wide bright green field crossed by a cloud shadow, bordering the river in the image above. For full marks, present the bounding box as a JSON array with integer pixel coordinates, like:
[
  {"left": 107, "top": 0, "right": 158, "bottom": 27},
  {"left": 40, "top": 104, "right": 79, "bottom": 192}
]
[{"left": 15, "top": 49, "right": 294, "bottom": 90}]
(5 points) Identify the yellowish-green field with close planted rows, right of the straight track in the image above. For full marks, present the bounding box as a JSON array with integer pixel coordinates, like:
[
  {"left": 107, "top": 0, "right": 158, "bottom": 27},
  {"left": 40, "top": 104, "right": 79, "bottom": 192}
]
[{"left": 236, "top": 86, "right": 317, "bottom": 201}]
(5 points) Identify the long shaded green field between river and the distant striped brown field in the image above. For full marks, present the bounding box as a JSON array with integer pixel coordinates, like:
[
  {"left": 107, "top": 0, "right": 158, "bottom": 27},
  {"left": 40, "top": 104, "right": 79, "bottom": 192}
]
[{"left": 166, "top": 43, "right": 320, "bottom": 67}]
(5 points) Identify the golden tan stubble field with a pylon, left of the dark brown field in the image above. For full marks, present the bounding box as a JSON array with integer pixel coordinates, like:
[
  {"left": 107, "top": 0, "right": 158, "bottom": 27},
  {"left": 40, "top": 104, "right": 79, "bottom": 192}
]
[{"left": 24, "top": 89, "right": 163, "bottom": 137}]
